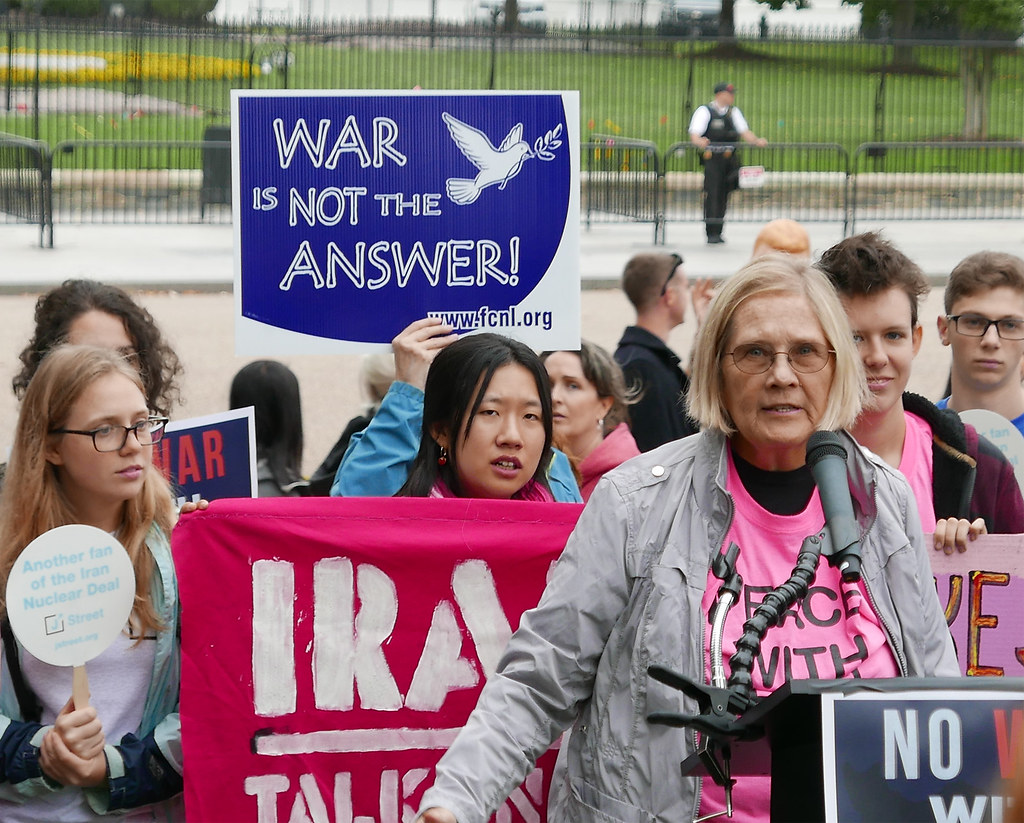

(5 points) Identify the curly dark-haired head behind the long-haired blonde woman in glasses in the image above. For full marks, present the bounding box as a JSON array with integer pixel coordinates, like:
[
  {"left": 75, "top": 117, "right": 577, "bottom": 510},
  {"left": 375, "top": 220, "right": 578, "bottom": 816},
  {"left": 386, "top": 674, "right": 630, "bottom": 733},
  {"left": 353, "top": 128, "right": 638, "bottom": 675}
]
[{"left": 11, "top": 279, "right": 181, "bottom": 417}]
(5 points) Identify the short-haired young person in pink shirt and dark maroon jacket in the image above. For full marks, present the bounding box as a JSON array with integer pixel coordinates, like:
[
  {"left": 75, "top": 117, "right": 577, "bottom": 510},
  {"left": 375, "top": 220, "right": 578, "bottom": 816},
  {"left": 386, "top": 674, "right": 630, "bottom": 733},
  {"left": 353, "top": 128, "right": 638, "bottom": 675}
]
[{"left": 817, "top": 232, "right": 1024, "bottom": 554}]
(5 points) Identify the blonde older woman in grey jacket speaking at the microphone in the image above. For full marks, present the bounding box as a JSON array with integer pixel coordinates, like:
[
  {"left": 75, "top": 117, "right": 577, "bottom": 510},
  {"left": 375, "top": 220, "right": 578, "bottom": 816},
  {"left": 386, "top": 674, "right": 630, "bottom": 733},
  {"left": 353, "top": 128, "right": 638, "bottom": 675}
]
[{"left": 411, "top": 255, "right": 959, "bottom": 823}]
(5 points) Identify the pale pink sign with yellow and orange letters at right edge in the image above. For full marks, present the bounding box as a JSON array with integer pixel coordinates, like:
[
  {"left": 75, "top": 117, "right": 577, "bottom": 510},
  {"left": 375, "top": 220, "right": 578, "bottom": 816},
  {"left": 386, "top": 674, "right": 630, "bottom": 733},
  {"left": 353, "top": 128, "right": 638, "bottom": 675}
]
[{"left": 925, "top": 534, "right": 1024, "bottom": 678}]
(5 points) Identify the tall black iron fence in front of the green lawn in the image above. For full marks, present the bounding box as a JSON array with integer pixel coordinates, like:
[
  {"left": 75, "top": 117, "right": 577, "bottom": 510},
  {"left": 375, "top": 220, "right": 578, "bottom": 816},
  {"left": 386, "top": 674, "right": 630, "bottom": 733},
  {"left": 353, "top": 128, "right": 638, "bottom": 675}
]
[{"left": 0, "top": 17, "right": 1024, "bottom": 155}]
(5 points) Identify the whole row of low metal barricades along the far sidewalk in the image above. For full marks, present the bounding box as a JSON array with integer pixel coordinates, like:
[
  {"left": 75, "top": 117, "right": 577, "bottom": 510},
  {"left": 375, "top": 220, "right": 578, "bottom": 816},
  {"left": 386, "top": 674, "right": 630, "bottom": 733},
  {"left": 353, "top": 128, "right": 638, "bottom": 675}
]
[{"left": 8, "top": 131, "right": 1024, "bottom": 246}]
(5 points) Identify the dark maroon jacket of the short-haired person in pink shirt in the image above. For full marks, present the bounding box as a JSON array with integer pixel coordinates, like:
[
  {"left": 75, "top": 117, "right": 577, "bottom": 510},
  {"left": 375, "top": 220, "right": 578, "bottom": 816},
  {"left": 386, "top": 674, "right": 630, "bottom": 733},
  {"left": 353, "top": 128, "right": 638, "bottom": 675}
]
[{"left": 903, "top": 392, "right": 1024, "bottom": 534}]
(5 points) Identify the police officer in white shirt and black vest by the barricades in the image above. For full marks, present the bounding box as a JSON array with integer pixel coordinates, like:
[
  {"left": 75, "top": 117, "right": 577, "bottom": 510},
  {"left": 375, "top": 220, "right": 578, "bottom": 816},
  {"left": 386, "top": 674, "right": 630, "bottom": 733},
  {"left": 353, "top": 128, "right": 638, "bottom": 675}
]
[{"left": 688, "top": 83, "right": 768, "bottom": 245}]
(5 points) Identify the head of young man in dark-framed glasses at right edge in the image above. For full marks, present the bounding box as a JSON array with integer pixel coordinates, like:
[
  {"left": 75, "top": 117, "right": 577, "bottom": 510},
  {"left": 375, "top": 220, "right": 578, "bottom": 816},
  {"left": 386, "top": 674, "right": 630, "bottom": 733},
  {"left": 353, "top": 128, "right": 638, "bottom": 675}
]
[{"left": 937, "top": 252, "right": 1024, "bottom": 434}]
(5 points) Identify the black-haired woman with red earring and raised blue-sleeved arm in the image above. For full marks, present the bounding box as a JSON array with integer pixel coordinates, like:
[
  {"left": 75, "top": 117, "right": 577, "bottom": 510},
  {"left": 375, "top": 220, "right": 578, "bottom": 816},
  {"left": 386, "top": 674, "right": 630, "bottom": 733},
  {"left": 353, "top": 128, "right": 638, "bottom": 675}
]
[{"left": 331, "top": 317, "right": 581, "bottom": 503}]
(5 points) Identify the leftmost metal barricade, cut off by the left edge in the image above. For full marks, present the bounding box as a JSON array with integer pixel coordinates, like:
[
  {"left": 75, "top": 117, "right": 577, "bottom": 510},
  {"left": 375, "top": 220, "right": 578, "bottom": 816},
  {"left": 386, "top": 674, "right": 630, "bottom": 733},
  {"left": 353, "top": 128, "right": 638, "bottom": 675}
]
[{"left": 0, "top": 134, "right": 53, "bottom": 248}]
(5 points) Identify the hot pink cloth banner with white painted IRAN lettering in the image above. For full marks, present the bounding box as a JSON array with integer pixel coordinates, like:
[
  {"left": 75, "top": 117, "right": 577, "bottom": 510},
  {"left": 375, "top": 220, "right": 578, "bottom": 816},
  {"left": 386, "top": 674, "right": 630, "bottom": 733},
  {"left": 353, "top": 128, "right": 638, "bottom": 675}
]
[{"left": 173, "top": 499, "right": 582, "bottom": 823}]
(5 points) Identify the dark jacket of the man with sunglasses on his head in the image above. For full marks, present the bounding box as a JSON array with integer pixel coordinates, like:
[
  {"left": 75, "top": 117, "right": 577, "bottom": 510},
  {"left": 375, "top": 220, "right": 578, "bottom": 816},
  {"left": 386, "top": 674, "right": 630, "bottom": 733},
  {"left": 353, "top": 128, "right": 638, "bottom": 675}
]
[{"left": 615, "top": 326, "right": 697, "bottom": 451}]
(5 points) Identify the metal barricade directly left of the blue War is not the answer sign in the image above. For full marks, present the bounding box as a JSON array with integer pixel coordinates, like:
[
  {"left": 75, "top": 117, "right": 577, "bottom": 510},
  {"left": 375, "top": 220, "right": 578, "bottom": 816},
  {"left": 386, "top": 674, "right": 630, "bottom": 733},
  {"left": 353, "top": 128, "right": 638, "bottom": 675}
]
[{"left": 53, "top": 140, "right": 231, "bottom": 223}]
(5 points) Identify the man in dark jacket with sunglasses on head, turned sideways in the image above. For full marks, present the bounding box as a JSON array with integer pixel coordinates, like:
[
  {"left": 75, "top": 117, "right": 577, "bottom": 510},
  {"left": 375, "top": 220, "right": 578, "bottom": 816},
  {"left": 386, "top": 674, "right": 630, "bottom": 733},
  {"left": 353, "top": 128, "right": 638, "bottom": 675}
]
[{"left": 615, "top": 254, "right": 712, "bottom": 451}]
